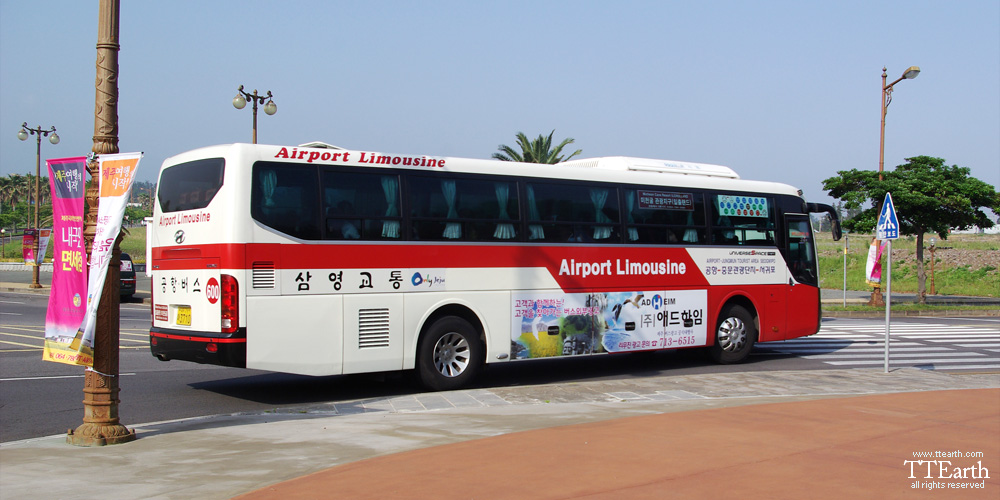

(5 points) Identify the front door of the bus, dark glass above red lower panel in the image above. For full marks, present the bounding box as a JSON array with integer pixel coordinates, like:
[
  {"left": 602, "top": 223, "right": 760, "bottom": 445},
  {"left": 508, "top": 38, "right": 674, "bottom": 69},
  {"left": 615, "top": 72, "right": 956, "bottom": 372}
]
[{"left": 784, "top": 214, "right": 820, "bottom": 338}]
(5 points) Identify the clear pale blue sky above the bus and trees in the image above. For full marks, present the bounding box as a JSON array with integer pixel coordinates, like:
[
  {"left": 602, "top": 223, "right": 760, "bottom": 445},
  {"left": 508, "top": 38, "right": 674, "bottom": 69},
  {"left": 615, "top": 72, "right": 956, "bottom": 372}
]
[{"left": 0, "top": 0, "right": 1000, "bottom": 202}]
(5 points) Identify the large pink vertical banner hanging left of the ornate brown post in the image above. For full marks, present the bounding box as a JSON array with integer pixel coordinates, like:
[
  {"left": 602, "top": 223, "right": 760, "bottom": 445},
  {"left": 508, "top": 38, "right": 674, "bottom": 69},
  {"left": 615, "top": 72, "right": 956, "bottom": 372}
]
[{"left": 42, "top": 156, "right": 93, "bottom": 365}]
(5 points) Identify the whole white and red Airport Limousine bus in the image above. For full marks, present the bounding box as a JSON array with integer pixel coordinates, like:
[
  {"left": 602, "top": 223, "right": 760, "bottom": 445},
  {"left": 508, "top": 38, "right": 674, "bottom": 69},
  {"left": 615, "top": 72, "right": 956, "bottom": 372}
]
[{"left": 150, "top": 143, "right": 839, "bottom": 390}]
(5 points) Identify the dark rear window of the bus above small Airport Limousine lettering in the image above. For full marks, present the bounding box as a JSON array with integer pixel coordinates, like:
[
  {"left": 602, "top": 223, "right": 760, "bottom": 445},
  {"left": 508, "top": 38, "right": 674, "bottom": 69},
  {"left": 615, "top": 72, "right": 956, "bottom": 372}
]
[{"left": 156, "top": 158, "right": 226, "bottom": 213}]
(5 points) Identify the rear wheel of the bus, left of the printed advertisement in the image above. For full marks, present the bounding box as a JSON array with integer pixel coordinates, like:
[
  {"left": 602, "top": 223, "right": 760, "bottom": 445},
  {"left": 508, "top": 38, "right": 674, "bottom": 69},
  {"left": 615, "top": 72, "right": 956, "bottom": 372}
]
[{"left": 417, "top": 316, "right": 485, "bottom": 391}]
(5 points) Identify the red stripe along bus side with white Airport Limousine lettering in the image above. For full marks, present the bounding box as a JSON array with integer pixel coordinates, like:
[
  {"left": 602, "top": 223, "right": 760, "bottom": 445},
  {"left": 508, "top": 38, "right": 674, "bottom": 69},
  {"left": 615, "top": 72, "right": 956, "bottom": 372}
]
[{"left": 153, "top": 242, "right": 708, "bottom": 289}]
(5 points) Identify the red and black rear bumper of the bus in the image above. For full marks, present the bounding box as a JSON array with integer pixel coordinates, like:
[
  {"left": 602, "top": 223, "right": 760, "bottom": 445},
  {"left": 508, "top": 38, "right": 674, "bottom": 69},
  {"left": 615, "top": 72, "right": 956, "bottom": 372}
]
[{"left": 149, "top": 327, "right": 247, "bottom": 368}]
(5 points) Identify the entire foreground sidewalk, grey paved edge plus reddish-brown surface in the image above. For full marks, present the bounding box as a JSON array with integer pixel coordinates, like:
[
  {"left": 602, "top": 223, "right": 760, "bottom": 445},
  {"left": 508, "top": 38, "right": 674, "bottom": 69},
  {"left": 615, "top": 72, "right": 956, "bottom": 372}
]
[{"left": 0, "top": 369, "right": 1000, "bottom": 499}]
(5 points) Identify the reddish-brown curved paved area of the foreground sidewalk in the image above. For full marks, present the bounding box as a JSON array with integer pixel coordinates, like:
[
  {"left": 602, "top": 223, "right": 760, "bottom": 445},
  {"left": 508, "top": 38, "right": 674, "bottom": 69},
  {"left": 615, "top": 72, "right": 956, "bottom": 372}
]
[{"left": 237, "top": 389, "right": 1000, "bottom": 500}]
